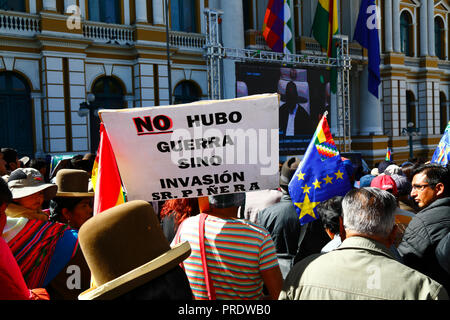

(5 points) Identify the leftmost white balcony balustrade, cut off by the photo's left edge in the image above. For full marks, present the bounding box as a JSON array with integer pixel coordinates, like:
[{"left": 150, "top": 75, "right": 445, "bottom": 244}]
[{"left": 0, "top": 10, "right": 41, "bottom": 36}]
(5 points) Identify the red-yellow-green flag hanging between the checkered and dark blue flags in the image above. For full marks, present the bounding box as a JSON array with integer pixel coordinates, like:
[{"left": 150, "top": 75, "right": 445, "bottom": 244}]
[{"left": 312, "top": 0, "right": 339, "bottom": 93}]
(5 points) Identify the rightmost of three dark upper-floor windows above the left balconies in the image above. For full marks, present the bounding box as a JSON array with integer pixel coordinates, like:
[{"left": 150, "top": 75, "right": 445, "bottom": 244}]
[{"left": 170, "top": 0, "right": 198, "bottom": 32}]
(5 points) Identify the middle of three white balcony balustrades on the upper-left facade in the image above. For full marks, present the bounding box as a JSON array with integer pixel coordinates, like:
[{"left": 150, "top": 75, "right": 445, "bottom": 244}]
[{"left": 83, "top": 21, "right": 135, "bottom": 45}]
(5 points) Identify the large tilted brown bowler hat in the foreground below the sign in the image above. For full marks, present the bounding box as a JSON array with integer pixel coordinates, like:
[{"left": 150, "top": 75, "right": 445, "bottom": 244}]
[{"left": 78, "top": 200, "right": 191, "bottom": 300}]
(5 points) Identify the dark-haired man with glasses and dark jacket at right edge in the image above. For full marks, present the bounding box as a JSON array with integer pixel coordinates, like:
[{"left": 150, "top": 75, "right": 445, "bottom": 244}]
[{"left": 398, "top": 164, "right": 450, "bottom": 290}]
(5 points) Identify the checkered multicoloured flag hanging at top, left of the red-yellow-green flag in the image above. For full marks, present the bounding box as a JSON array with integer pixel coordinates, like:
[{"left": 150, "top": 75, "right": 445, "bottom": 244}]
[{"left": 263, "top": 0, "right": 294, "bottom": 53}]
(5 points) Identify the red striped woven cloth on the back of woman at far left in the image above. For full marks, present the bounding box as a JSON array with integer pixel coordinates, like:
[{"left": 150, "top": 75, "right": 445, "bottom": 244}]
[{"left": 8, "top": 219, "right": 69, "bottom": 288}]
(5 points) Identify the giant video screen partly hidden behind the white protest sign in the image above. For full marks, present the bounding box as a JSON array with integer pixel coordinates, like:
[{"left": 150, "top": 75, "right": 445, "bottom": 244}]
[{"left": 236, "top": 63, "right": 330, "bottom": 156}]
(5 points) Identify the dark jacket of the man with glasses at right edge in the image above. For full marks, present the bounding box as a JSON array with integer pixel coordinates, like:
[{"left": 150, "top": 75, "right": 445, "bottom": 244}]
[{"left": 398, "top": 197, "right": 450, "bottom": 290}]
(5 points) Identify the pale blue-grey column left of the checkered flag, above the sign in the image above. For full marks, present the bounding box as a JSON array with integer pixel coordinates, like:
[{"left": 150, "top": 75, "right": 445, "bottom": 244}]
[{"left": 221, "top": 0, "right": 245, "bottom": 99}]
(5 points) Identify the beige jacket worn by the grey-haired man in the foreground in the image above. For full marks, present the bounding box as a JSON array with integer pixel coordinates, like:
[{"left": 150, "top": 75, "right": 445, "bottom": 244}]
[{"left": 279, "top": 237, "right": 449, "bottom": 300}]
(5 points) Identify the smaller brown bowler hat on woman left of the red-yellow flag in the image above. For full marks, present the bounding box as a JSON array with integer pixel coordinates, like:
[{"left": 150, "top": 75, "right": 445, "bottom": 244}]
[{"left": 55, "top": 169, "right": 94, "bottom": 198}]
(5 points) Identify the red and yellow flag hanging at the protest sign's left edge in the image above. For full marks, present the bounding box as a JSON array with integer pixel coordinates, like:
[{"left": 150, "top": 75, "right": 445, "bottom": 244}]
[{"left": 92, "top": 123, "right": 125, "bottom": 215}]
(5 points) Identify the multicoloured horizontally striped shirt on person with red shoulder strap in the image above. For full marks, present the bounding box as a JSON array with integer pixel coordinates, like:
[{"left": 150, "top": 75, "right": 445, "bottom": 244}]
[{"left": 172, "top": 215, "right": 278, "bottom": 300}]
